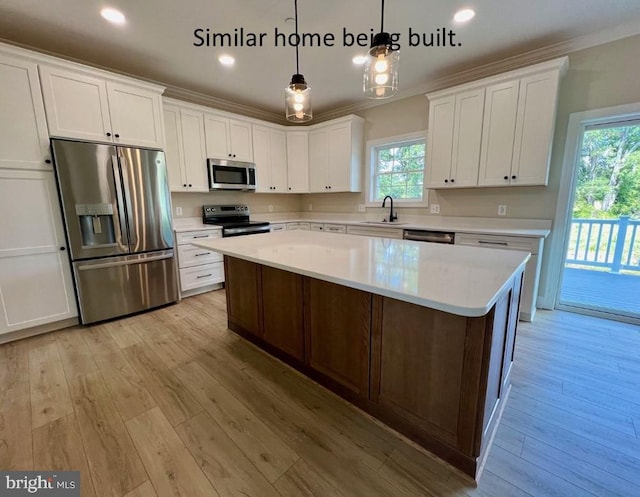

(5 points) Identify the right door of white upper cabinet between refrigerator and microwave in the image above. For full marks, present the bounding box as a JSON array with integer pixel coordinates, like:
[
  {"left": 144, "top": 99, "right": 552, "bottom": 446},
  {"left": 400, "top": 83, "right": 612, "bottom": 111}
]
[{"left": 180, "top": 109, "right": 209, "bottom": 192}]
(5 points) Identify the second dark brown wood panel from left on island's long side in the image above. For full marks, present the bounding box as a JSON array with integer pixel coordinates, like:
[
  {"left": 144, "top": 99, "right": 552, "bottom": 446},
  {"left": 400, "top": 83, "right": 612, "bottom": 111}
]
[{"left": 262, "top": 266, "right": 304, "bottom": 362}]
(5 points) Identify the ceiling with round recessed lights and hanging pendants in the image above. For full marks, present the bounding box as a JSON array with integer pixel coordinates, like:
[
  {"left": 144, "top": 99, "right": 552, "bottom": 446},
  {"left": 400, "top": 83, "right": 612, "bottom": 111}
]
[{"left": 0, "top": 0, "right": 640, "bottom": 119}]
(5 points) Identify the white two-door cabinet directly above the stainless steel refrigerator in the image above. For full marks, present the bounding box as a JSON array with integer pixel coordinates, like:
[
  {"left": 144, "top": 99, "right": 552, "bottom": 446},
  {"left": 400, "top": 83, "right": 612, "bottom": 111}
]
[{"left": 40, "top": 65, "right": 163, "bottom": 148}]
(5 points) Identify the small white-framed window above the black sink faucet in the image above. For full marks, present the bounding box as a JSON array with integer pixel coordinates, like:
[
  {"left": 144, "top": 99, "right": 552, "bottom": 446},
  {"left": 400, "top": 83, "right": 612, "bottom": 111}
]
[{"left": 367, "top": 133, "right": 427, "bottom": 205}]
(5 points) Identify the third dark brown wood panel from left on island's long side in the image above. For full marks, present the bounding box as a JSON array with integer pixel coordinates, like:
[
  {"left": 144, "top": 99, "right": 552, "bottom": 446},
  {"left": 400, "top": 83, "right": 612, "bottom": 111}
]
[{"left": 304, "top": 277, "right": 371, "bottom": 398}]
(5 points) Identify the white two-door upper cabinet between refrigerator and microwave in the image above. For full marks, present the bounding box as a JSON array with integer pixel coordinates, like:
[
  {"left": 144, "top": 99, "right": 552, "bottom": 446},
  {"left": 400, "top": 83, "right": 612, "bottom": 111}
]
[{"left": 163, "top": 103, "right": 209, "bottom": 192}]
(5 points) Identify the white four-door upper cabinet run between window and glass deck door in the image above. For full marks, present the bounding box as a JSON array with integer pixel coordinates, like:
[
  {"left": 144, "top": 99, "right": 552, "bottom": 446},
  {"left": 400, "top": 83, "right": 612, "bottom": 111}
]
[{"left": 426, "top": 57, "right": 568, "bottom": 188}]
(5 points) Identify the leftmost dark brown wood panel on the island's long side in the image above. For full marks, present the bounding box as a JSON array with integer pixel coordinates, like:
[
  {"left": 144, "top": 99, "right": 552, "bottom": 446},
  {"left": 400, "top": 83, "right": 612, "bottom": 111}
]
[{"left": 224, "top": 257, "right": 262, "bottom": 337}]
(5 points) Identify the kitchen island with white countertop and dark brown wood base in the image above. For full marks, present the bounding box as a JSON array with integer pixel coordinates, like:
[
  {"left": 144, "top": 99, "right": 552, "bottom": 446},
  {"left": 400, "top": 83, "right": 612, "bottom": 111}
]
[{"left": 198, "top": 231, "right": 529, "bottom": 478}]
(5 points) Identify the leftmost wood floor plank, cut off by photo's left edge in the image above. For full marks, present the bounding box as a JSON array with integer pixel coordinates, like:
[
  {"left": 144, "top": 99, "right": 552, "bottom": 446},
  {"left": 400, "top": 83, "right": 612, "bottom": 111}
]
[{"left": 0, "top": 340, "right": 33, "bottom": 470}]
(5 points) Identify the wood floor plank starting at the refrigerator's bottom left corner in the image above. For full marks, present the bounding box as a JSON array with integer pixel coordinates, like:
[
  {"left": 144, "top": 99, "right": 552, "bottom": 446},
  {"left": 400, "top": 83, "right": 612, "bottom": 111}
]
[{"left": 85, "top": 328, "right": 156, "bottom": 420}]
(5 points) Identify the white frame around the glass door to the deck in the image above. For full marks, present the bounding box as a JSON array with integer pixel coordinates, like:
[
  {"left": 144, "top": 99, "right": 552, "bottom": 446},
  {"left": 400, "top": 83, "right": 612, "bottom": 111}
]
[{"left": 544, "top": 103, "right": 640, "bottom": 308}]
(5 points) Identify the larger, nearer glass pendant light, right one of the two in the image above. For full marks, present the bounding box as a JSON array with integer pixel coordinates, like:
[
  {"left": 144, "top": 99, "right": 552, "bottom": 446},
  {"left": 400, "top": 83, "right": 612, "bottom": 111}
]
[{"left": 363, "top": 0, "right": 400, "bottom": 98}]
